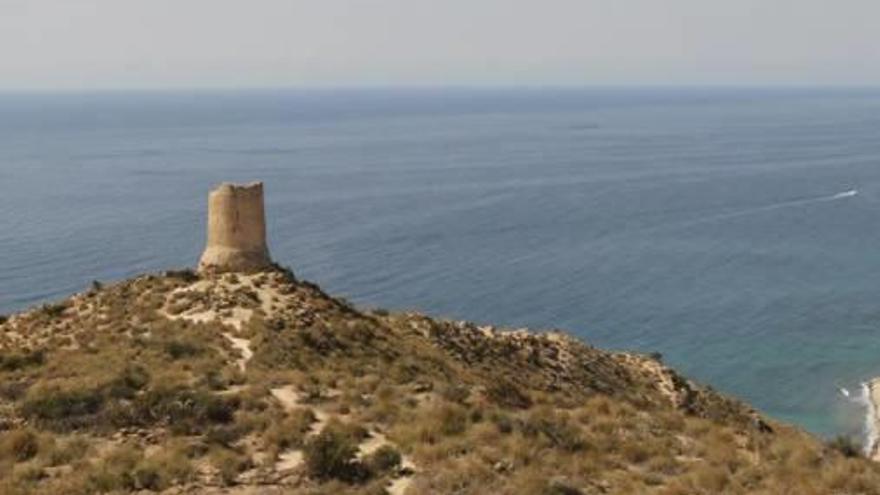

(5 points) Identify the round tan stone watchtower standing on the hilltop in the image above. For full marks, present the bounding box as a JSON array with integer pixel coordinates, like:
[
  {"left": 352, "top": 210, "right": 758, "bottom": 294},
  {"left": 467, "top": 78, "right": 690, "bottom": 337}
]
[{"left": 199, "top": 182, "right": 272, "bottom": 273}]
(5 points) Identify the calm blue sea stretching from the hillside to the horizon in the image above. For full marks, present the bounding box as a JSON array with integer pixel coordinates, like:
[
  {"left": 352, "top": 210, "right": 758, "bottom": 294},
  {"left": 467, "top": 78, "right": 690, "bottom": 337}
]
[{"left": 0, "top": 89, "right": 880, "bottom": 434}]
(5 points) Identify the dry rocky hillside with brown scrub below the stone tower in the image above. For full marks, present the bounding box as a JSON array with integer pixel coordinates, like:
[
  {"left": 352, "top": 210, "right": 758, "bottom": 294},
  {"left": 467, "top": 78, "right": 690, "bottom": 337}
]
[{"left": 0, "top": 269, "right": 880, "bottom": 495}]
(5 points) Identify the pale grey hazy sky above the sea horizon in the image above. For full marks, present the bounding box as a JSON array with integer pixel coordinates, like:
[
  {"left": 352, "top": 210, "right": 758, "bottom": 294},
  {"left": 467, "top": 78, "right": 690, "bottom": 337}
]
[{"left": 0, "top": 0, "right": 880, "bottom": 89}]
